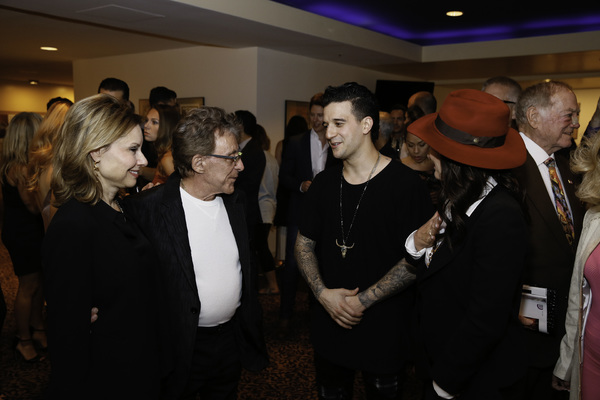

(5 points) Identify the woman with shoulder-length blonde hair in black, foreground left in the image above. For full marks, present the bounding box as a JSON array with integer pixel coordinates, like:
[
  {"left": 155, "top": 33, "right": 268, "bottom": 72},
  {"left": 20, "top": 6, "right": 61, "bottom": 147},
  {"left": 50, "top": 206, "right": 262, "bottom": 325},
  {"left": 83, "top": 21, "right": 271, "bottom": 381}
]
[{"left": 43, "top": 94, "right": 165, "bottom": 399}]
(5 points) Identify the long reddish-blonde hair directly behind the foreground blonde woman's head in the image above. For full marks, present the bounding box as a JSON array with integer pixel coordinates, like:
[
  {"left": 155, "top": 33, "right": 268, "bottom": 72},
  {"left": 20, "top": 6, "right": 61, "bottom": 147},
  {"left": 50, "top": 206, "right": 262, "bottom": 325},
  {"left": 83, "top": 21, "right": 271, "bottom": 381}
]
[{"left": 27, "top": 102, "right": 71, "bottom": 192}]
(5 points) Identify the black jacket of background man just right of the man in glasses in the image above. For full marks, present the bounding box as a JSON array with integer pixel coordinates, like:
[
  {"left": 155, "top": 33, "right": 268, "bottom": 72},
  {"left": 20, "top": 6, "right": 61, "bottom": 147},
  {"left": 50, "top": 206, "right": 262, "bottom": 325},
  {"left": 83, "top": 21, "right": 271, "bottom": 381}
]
[{"left": 235, "top": 139, "right": 267, "bottom": 230}]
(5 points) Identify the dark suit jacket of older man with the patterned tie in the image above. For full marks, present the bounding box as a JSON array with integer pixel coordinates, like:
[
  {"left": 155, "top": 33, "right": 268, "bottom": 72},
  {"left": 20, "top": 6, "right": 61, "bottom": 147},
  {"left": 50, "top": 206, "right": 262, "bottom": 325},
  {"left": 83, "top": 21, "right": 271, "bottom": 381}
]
[{"left": 514, "top": 153, "right": 584, "bottom": 368}]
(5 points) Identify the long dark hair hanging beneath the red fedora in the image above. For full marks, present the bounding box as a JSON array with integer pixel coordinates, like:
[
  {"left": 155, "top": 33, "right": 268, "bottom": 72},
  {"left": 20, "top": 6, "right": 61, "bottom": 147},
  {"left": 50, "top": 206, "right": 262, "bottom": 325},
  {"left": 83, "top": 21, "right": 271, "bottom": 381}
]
[{"left": 438, "top": 154, "right": 523, "bottom": 248}]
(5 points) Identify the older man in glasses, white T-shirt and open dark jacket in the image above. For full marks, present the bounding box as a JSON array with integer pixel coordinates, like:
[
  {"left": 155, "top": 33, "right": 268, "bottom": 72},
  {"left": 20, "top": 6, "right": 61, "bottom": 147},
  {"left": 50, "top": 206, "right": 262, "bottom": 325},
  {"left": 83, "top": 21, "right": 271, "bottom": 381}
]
[{"left": 127, "top": 107, "right": 268, "bottom": 400}]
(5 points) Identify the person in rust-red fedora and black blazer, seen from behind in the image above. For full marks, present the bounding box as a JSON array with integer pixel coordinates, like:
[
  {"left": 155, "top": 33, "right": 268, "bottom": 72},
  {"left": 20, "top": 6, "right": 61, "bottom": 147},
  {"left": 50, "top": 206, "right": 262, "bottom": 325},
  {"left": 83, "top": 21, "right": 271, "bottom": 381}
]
[{"left": 406, "top": 89, "right": 527, "bottom": 400}]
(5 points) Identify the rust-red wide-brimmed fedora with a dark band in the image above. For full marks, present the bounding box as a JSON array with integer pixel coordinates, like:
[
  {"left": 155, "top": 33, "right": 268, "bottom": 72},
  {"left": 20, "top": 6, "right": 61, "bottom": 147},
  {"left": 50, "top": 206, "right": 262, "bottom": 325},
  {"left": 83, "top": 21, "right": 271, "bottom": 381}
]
[{"left": 408, "top": 89, "right": 527, "bottom": 169}]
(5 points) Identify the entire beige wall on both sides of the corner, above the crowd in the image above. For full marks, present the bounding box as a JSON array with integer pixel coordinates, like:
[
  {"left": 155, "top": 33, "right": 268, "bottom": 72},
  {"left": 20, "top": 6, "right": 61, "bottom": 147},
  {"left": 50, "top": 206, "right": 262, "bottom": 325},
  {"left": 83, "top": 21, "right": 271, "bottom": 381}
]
[{"left": 73, "top": 47, "right": 406, "bottom": 150}]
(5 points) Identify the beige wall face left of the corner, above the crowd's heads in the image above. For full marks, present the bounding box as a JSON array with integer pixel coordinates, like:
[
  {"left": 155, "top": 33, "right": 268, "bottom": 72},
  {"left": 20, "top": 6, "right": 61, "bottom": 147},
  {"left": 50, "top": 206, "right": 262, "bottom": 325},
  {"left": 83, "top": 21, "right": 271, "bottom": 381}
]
[{"left": 73, "top": 47, "right": 257, "bottom": 112}]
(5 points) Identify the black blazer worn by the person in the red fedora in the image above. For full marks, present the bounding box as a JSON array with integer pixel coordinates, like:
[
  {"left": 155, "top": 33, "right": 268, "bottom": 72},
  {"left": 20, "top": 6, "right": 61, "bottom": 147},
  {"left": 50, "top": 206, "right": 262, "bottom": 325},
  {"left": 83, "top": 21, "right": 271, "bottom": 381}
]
[{"left": 416, "top": 186, "right": 527, "bottom": 399}]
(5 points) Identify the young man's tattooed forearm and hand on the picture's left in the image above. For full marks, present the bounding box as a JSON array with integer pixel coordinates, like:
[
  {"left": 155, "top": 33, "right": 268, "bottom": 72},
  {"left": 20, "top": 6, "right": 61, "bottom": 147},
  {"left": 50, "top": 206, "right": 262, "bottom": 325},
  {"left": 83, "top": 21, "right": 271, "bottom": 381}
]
[{"left": 294, "top": 233, "right": 362, "bottom": 329}]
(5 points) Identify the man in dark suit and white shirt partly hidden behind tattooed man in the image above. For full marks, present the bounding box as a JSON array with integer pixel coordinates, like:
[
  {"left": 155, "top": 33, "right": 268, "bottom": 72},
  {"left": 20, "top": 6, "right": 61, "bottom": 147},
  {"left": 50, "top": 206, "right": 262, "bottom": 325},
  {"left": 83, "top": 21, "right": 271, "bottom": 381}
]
[{"left": 279, "top": 93, "right": 337, "bottom": 336}]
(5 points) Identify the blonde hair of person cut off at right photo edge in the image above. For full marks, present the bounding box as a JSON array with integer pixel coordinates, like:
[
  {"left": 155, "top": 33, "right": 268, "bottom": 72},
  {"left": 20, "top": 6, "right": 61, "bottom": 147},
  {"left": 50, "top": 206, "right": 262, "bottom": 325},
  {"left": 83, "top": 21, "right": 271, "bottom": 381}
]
[{"left": 571, "top": 134, "right": 600, "bottom": 206}]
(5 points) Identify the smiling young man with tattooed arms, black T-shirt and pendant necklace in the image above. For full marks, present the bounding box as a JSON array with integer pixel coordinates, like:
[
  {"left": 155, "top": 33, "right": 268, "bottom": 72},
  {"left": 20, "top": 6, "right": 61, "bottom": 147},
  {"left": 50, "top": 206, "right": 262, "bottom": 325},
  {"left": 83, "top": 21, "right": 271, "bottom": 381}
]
[{"left": 295, "top": 83, "right": 433, "bottom": 399}]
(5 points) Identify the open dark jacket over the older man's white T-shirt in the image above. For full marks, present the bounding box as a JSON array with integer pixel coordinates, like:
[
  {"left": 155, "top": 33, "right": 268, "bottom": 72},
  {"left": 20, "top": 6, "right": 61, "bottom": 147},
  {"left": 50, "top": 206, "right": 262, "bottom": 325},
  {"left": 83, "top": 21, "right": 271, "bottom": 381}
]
[{"left": 125, "top": 173, "right": 268, "bottom": 398}]
